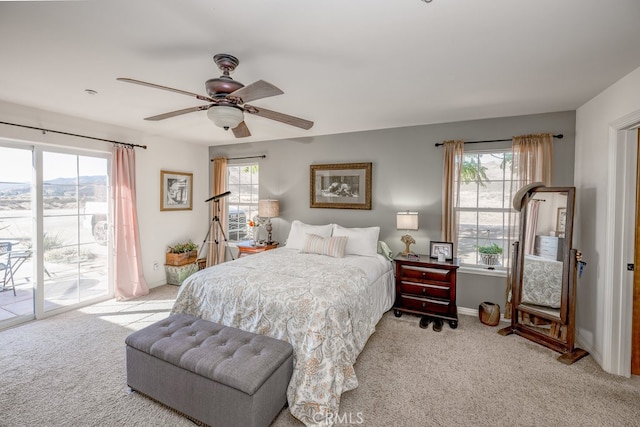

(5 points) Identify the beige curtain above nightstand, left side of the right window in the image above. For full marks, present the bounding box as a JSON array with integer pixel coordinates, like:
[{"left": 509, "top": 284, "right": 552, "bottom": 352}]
[{"left": 442, "top": 140, "right": 464, "bottom": 257}]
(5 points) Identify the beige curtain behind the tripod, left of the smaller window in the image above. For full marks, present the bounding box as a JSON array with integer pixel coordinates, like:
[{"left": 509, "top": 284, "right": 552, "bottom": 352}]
[{"left": 207, "top": 157, "right": 227, "bottom": 267}]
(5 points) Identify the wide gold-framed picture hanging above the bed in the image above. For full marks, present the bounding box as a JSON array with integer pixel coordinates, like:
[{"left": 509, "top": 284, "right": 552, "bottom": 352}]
[{"left": 310, "top": 163, "right": 372, "bottom": 209}]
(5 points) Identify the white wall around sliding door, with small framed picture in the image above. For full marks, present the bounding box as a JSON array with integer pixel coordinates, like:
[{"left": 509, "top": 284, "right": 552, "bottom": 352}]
[{"left": 0, "top": 102, "right": 209, "bottom": 287}]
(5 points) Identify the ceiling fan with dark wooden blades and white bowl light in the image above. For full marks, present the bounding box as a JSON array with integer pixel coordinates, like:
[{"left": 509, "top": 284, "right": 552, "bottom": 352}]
[{"left": 117, "top": 53, "right": 313, "bottom": 138}]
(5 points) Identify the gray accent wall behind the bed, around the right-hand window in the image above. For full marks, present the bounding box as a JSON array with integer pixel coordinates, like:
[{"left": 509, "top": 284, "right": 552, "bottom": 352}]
[{"left": 209, "top": 111, "right": 575, "bottom": 310}]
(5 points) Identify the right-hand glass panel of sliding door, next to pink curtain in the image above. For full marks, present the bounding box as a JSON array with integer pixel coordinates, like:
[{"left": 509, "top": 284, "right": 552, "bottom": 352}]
[{"left": 42, "top": 151, "right": 109, "bottom": 311}]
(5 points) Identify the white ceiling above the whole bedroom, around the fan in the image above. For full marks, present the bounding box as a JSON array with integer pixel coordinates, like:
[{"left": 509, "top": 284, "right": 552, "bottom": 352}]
[{"left": 0, "top": 0, "right": 640, "bottom": 145}]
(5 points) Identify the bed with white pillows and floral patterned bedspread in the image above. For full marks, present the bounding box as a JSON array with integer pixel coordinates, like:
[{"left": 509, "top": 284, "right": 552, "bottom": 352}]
[{"left": 172, "top": 221, "right": 395, "bottom": 425}]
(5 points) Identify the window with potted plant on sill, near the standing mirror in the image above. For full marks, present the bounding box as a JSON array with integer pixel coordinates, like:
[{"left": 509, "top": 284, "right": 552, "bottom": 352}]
[{"left": 458, "top": 150, "right": 516, "bottom": 269}]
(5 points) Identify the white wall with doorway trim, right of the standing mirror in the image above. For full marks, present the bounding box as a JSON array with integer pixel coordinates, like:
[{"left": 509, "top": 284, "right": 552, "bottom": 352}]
[{"left": 574, "top": 68, "right": 640, "bottom": 375}]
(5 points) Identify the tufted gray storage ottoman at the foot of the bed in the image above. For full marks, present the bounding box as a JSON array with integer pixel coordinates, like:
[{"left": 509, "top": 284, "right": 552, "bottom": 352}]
[{"left": 125, "top": 314, "right": 293, "bottom": 427}]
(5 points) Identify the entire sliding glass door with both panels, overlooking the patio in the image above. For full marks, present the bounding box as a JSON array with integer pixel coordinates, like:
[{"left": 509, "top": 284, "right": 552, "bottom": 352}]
[{"left": 0, "top": 140, "right": 112, "bottom": 328}]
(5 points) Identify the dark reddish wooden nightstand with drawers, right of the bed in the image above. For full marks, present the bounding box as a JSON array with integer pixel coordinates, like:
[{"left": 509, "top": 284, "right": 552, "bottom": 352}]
[{"left": 393, "top": 255, "right": 460, "bottom": 329}]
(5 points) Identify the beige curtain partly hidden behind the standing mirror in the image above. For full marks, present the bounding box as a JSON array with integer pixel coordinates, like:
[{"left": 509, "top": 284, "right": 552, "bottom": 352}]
[{"left": 504, "top": 133, "right": 553, "bottom": 319}]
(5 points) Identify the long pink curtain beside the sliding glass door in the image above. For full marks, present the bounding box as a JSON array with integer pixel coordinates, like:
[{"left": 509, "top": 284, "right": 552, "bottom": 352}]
[{"left": 111, "top": 145, "right": 149, "bottom": 301}]
